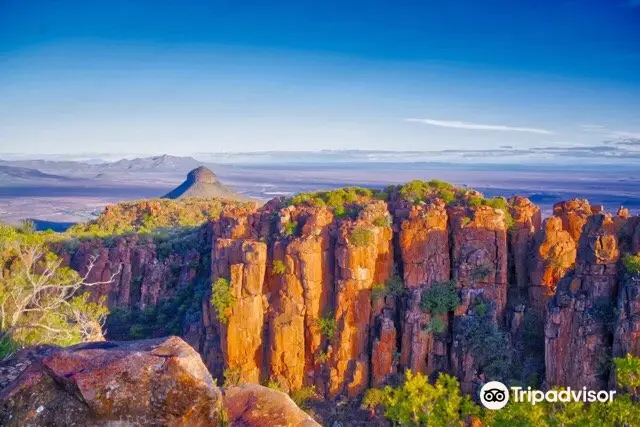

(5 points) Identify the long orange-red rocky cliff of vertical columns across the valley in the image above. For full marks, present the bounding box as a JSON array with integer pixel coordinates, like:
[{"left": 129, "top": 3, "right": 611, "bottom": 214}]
[{"left": 48, "top": 181, "right": 640, "bottom": 399}]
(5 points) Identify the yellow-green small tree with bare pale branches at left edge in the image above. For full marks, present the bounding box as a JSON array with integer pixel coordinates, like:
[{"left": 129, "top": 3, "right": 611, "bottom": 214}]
[{"left": 0, "top": 225, "right": 114, "bottom": 348}]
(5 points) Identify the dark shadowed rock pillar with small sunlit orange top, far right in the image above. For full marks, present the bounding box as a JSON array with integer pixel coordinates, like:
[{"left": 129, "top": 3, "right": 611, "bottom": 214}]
[{"left": 545, "top": 214, "right": 619, "bottom": 389}]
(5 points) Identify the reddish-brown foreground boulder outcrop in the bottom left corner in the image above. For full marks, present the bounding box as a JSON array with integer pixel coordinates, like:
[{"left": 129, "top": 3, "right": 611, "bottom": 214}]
[{"left": 0, "top": 337, "right": 317, "bottom": 426}]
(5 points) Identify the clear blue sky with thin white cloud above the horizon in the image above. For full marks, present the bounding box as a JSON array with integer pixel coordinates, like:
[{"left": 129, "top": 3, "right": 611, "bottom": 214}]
[{"left": 0, "top": 0, "right": 640, "bottom": 154}]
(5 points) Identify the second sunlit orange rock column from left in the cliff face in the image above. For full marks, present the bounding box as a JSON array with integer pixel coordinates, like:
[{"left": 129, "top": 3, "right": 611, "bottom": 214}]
[{"left": 267, "top": 207, "right": 333, "bottom": 389}]
